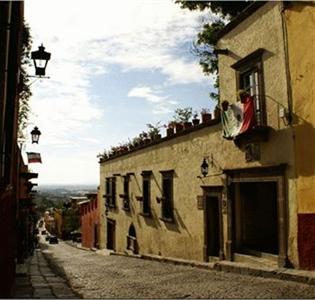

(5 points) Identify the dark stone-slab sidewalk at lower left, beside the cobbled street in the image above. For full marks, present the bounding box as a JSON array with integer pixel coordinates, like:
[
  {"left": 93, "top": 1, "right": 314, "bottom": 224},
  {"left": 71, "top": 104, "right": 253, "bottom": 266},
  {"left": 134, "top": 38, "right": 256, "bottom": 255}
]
[{"left": 13, "top": 249, "right": 79, "bottom": 299}]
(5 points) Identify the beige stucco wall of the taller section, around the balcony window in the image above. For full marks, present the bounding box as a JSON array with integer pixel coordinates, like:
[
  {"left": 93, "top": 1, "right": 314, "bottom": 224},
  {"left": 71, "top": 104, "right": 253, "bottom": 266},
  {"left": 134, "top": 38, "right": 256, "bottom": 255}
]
[{"left": 217, "top": 1, "right": 298, "bottom": 265}]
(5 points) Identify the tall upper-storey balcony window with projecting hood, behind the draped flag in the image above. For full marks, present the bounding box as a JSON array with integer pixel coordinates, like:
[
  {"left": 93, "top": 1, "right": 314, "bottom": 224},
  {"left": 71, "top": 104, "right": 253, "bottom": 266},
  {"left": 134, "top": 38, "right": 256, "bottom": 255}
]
[{"left": 231, "top": 49, "right": 267, "bottom": 126}]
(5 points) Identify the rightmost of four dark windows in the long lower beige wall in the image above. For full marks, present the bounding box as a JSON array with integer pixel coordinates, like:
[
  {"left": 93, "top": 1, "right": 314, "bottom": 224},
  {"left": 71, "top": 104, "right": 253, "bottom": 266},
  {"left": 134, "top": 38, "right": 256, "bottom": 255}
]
[{"left": 161, "top": 171, "right": 174, "bottom": 221}]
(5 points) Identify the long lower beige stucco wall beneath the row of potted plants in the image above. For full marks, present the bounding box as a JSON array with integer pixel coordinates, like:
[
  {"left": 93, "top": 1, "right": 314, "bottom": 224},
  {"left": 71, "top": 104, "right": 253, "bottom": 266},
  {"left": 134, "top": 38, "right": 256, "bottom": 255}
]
[{"left": 99, "top": 111, "right": 296, "bottom": 261}]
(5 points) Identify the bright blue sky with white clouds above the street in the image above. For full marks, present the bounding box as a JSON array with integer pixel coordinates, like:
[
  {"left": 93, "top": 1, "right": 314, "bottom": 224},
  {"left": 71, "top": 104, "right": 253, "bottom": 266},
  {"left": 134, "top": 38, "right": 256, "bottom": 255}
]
[{"left": 23, "top": 0, "right": 214, "bottom": 185}]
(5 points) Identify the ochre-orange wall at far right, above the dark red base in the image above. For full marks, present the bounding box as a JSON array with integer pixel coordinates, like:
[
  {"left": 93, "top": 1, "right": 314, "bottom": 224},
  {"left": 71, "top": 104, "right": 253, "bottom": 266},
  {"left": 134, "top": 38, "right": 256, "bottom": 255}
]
[{"left": 285, "top": 3, "right": 315, "bottom": 213}]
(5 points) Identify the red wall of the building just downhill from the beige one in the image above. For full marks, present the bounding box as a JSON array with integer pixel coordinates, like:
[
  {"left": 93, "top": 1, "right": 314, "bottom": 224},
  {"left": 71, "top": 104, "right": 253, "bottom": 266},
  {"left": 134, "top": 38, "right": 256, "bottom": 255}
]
[{"left": 80, "top": 195, "right": 99, "bottom": 248}]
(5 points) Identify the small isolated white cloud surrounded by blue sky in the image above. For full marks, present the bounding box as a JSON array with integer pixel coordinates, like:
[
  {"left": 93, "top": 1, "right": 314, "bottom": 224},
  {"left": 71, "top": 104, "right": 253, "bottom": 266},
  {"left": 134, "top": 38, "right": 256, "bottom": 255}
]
[{"left": 128, "top": 86, "right": 177, "bottom": 115}]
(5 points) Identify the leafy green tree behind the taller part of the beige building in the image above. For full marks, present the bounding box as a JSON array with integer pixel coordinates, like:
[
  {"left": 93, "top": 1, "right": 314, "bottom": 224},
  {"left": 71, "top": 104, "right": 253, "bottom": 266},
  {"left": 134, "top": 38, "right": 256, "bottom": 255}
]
[{"left": 175, "top": 0, "right": 252, "bottom": 101}]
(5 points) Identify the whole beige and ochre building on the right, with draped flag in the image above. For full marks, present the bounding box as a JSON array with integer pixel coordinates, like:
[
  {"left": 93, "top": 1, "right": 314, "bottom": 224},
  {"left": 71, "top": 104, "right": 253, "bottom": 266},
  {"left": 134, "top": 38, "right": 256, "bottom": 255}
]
[{"left": 99, "top": 2, "right": 315, "bottom": 269}]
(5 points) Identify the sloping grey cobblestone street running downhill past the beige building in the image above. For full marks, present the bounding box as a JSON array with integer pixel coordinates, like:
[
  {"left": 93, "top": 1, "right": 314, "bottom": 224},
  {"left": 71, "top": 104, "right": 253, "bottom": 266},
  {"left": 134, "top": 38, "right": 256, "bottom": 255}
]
[{"left": 44, "top": 242, "right": 315, "bottom": 298}]
